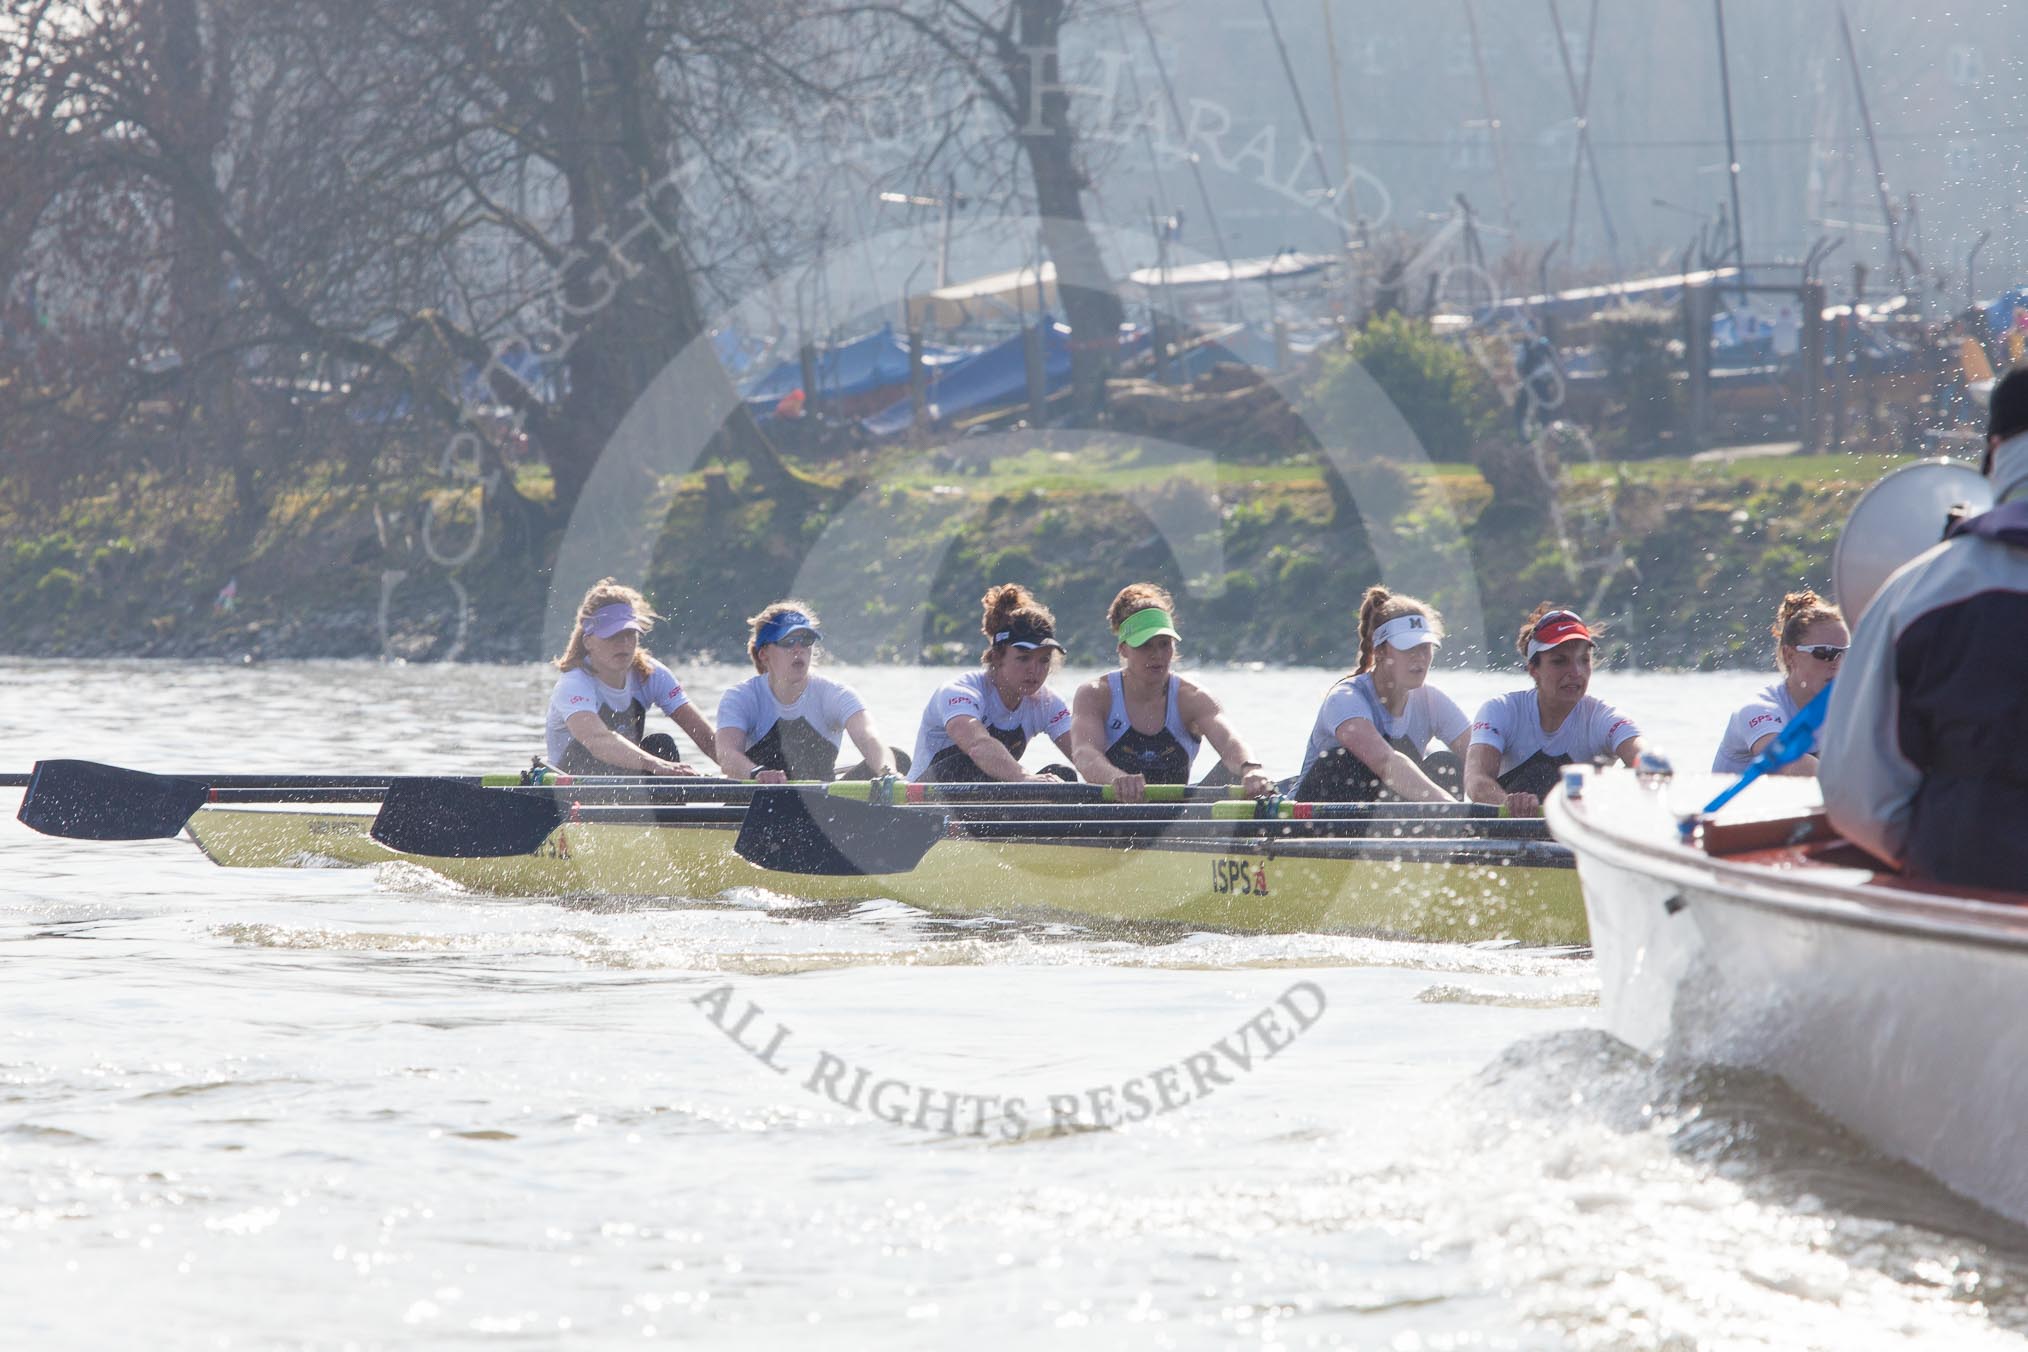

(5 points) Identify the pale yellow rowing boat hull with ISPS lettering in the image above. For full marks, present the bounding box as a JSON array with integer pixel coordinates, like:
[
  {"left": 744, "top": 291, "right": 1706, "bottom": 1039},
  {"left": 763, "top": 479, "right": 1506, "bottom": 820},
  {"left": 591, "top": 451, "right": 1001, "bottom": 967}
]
[{"left": 189, "top": 807, "right": 1586, "bottom": 945}]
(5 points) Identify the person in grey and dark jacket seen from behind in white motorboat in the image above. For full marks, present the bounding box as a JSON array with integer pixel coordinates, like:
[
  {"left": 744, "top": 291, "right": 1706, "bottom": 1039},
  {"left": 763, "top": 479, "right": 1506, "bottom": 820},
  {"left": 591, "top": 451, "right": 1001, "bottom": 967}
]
[{"left": 1819, "top": 369, "right": 2028, "bottom": 892}]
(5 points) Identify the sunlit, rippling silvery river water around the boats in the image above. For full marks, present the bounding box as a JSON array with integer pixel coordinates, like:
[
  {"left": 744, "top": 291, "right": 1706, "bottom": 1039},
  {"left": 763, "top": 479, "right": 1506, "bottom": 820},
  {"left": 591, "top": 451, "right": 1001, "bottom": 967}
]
[{"left": 0, "top": 663, "right": 2028, "bottom": 1352}]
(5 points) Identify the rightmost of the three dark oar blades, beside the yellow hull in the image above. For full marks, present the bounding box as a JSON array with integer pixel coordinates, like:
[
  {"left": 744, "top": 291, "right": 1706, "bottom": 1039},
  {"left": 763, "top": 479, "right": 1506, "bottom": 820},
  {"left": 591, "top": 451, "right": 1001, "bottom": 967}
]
[{"left": 732, "top": 788, "right": 947, "bottom": 878}]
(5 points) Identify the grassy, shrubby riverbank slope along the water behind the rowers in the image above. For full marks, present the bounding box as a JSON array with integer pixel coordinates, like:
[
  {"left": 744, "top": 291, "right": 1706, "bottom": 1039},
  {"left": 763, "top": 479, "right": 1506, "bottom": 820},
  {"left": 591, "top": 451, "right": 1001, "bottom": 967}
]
[{"left": 0, "top": 438, "right": 1894, "bottom": 667}]
